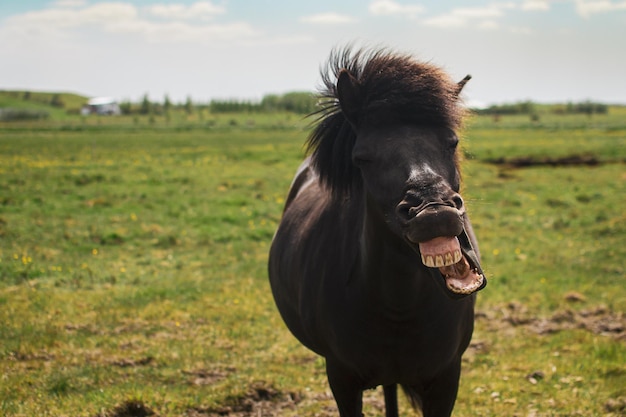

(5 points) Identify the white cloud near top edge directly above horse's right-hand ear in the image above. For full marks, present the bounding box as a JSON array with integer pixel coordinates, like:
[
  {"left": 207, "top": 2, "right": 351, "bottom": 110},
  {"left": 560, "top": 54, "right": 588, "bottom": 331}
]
[{"left": 424, "top": 2, "right": 516, "bottom": 30}]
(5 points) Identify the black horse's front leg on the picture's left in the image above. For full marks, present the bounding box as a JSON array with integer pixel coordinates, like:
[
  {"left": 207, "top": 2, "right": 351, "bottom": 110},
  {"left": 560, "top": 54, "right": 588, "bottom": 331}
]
[{"left": 326, "top": 358, "right": 363, "bottom": 417}]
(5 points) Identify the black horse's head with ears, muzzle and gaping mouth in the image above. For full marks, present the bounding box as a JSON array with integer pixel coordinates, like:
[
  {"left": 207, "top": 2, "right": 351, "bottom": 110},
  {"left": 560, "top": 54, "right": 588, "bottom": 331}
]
[{"left": 335, "top": 52, "right": 486, "bottom": 297}]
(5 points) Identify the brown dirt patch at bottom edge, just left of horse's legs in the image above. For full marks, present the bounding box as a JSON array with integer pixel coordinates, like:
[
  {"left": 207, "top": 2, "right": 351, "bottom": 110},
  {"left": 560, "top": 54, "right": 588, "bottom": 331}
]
[{"left": 186, "top": 381, "right": 302, "bottom": 417}]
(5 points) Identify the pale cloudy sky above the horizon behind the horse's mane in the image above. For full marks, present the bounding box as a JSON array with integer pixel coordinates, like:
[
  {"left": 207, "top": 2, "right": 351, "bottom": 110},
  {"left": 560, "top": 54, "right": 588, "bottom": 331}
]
[{"left": 0, "top": 0, "right": 626, "bottom": 104}]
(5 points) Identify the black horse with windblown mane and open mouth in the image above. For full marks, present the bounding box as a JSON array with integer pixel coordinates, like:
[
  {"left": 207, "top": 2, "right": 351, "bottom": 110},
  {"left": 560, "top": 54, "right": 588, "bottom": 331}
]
[{"left": 269, "top": 48, "right": 486, "bottom": 417}]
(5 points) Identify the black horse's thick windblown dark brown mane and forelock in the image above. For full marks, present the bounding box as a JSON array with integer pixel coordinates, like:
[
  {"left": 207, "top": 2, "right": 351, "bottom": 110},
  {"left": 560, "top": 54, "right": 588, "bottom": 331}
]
[{"left": 307, "top": 47, "right": 464, "bottom": 196}]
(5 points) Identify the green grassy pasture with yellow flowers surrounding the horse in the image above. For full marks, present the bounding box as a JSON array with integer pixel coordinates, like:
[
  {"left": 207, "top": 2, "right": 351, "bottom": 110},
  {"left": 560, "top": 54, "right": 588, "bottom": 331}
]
[{"left": 0, "top": 112, "right": 626, "bottom": 417}]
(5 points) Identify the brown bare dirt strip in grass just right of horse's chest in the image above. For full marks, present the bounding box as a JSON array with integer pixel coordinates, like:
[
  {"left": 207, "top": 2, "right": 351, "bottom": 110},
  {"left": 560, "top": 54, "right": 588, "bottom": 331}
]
[{"left": 476, "top": 302, "right": 626, "bottom": 342}]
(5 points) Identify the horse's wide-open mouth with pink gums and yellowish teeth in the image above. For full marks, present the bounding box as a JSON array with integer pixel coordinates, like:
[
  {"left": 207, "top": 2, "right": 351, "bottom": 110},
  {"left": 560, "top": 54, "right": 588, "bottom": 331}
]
[{"left": 419, "top": 232, "right": 487, "bottom": 296}]
